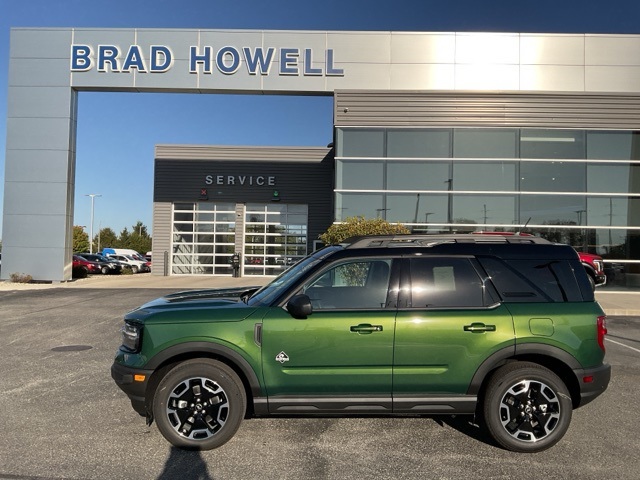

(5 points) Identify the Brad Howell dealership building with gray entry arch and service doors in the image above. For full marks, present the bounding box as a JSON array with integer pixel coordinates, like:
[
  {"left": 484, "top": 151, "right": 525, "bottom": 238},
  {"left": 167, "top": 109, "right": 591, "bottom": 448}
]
[{"left": 1, "top": 29, "right": 640, "bottom": 286}]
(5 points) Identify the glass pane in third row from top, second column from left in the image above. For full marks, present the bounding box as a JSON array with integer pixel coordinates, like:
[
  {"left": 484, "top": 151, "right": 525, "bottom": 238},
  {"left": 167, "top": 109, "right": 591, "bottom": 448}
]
[{"left": 387, "top": 194, "right": 448, "bottom": 223}]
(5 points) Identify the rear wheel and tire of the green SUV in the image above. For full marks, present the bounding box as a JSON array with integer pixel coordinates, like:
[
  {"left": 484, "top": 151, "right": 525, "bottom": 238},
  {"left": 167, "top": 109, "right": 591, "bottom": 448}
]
[{"left": 482, "top": 362, "right": 573, "bottom": 453}]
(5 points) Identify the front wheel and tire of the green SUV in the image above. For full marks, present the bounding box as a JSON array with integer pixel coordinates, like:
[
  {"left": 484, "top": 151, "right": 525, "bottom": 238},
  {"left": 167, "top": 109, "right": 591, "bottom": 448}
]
[{"left": 153, "top": 359, "right": 247, "bottom": 450}]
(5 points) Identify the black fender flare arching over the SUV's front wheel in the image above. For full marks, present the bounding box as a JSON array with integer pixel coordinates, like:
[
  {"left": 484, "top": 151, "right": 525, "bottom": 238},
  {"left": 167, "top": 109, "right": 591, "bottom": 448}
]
[{"left": 145, "top": 342, "right": 263, "bottom": 398}]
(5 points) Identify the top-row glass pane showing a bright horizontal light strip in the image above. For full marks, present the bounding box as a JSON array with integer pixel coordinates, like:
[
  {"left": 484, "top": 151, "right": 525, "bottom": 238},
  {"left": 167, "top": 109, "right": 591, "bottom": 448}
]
[{"left": 520, "top": 129, "right": 586, "bottom": 159}]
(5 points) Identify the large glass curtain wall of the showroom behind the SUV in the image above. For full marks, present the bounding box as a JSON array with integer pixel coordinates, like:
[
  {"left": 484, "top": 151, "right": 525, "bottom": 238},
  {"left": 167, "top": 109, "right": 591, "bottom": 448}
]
[{"left": 335, "top": 128, "right": 640, "bottom": 286}]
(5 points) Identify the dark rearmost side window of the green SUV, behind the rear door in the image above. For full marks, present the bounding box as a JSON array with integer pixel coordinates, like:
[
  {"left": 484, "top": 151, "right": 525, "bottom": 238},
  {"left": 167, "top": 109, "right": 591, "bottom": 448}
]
[{"left": 478, "top": 257, "right": 582, "bottom": 303}]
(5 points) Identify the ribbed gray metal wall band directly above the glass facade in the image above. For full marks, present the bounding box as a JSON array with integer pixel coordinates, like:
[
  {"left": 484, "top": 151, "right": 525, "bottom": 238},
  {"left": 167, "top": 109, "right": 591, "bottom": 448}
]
[{"left": 334, "top": 91, "right": 640, "bottom": 129}]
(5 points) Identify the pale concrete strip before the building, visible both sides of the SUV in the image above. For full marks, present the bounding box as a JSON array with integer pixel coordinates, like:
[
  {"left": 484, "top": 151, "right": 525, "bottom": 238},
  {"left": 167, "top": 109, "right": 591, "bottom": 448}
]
[{"left": 0, "top": 273, "right": 640, "bottom": 316}]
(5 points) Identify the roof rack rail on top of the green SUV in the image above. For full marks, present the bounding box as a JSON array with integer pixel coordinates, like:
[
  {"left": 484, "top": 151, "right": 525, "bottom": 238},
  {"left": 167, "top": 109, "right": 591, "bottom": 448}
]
[{"left": 341, "top": 233, "right": 552, "bottom": 248}]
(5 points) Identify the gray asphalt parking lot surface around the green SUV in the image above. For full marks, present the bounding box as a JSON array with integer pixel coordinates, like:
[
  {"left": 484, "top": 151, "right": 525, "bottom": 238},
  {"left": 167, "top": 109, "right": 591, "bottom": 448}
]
[{"left": 0, "top": 284, "right": 640, "bottom": 480}]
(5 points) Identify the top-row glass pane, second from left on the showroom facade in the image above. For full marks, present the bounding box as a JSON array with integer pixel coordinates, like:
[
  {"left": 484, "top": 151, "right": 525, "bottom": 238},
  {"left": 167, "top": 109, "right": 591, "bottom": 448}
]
[{"left": 387, "top": 129, "right": 451, "bottom": 158}]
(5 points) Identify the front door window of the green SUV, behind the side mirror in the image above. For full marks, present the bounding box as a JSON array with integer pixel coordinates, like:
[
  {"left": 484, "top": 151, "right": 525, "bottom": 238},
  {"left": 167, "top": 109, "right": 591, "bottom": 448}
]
[{"left": 303, "top": 258, "right": 392, "bottom": 310}]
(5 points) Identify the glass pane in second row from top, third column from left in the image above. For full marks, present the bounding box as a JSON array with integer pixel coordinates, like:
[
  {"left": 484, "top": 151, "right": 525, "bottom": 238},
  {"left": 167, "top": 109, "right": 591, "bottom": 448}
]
[{"left": 453, "top": 162, "right": 517, "bottom": 192}]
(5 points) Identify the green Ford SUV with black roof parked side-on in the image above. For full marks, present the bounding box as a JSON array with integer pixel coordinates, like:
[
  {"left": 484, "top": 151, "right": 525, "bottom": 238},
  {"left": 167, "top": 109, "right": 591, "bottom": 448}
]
[{"left": 111, "top": 235, "right": 611, "bottom": 452}]
